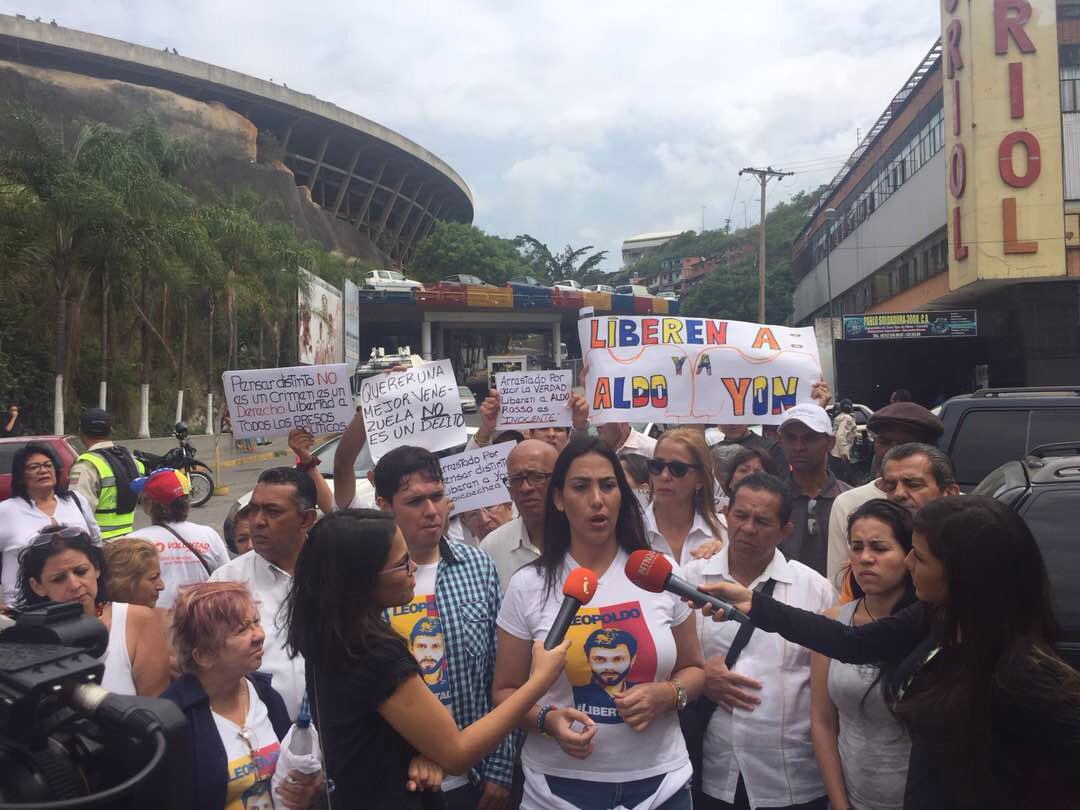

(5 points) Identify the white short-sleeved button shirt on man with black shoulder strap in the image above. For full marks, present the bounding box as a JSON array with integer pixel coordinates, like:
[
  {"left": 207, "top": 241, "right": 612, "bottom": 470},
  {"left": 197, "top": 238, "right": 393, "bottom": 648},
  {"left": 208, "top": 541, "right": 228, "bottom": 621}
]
[{"left": 686, "top": 548, "right": 837, "bottom": 807}]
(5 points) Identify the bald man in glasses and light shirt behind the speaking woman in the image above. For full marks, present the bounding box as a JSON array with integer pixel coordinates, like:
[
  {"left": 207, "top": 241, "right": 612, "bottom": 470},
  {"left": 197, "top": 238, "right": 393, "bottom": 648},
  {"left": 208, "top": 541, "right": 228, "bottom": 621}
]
[{"left": 480, "top": 438, "right": 558, "bottom": 591}]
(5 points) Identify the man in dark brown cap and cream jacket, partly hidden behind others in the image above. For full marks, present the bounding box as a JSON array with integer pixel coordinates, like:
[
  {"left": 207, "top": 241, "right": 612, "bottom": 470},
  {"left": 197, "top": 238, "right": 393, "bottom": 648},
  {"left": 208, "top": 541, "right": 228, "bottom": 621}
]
[{"left": 825, "top": 402, "right": 945, "bottom": 584}]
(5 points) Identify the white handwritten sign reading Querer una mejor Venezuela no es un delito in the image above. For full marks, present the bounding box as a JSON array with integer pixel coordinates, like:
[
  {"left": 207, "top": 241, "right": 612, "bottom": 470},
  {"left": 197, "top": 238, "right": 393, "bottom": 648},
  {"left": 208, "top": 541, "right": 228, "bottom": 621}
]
[{"left": 360, "top": 360, "right": 467, "bottom": 461}]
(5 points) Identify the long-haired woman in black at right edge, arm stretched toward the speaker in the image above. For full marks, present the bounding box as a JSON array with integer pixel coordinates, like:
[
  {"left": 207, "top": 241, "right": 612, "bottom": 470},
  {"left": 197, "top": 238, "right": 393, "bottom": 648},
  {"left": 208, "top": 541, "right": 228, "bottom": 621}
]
[{"left": 702, "top": 496, "right": 1080, "bottom": 810}]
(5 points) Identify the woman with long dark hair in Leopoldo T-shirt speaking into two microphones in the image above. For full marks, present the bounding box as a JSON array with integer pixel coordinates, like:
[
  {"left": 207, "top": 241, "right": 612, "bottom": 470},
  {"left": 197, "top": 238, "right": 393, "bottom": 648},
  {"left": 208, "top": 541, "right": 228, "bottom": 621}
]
[{"left": 492, "top": 436, "right": 704, "bottom": 810}]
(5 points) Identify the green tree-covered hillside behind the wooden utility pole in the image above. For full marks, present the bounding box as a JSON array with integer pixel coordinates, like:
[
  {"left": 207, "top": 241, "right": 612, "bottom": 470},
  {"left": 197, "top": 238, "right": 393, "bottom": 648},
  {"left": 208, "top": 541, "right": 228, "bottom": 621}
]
[{"left": 630, "top": 192, "right": 818, "bottom": 324}]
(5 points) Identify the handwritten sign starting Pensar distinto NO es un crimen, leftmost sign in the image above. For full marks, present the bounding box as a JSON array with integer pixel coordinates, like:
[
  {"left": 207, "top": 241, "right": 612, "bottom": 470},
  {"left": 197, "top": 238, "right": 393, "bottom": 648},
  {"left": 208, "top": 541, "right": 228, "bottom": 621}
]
[{"left": 221, "top": 363, "right": 356, "bottom": 438}]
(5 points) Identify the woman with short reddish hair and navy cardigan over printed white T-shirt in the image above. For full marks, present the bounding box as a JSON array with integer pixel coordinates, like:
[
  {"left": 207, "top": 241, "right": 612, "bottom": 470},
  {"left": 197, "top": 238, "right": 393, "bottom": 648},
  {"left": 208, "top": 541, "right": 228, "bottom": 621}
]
[{"left": 162, "top": 582, "right": 323, "bottom": 810}]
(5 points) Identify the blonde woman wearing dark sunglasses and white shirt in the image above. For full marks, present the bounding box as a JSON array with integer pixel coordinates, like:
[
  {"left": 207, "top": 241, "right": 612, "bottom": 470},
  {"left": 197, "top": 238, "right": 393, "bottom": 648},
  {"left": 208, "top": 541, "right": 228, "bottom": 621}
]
[{"left": 645, "top": 428, "right": 727, "bottom": 565}]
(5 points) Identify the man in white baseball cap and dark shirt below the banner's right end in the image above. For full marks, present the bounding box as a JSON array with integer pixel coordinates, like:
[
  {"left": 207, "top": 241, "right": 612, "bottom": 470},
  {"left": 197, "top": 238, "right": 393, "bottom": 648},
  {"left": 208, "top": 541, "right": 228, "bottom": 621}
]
[{"left": 779, "top": 403, "right": 851, "bottom": 576}]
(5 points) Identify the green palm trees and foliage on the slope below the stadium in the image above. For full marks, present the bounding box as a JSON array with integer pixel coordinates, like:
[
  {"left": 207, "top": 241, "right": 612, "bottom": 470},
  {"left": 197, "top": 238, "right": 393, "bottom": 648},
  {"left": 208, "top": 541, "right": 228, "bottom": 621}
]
[{"left": 0, "top": 105, "right": 367, "bottom": 434}]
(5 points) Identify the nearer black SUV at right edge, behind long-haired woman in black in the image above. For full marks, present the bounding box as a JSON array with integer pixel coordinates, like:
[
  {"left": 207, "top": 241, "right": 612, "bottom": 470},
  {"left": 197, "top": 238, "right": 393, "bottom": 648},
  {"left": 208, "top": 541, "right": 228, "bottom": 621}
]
[{"left": 973, "top": 442, "right": 1080, "bottom": 669}]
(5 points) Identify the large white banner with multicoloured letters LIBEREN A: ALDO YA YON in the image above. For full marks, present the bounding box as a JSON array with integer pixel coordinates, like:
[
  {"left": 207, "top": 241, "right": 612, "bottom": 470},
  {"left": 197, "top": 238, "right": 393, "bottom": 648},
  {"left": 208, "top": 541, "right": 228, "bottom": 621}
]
[{"left": 578, "top": 315, "right": 822, "bottom": 424}]
